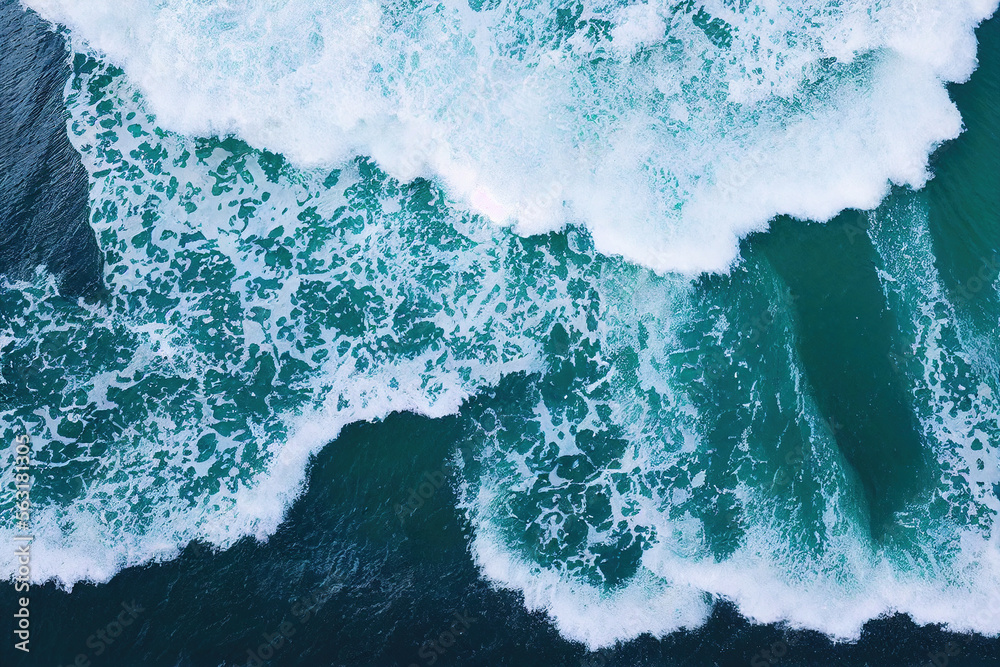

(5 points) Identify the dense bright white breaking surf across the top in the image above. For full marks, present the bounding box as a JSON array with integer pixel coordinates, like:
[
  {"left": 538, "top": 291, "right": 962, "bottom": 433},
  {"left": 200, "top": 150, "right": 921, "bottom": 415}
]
[{"left": 19, "top": 0, "right": 997, "bottom": 274}]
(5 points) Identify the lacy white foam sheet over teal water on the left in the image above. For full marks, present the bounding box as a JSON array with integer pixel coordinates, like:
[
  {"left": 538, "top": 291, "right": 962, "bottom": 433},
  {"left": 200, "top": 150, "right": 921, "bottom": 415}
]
[{"left": 0, "top": 63, "right": 552, "bottom": 587}]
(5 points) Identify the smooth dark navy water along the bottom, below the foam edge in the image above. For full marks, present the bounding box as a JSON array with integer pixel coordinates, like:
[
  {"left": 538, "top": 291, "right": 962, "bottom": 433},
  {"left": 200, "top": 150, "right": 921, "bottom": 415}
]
[{"left": 0, "top": 408, "right": 1000, "bottom": 667}]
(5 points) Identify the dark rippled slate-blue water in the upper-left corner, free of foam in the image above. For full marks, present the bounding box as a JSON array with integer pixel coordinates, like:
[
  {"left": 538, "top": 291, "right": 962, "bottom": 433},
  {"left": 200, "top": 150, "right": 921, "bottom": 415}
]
[{"left": 0, "top": 0, "right": 102, "bottom": 296}]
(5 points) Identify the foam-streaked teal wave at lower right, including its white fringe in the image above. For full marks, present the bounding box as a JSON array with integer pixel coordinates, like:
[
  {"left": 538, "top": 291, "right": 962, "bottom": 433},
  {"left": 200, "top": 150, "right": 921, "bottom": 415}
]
[{"left": 461, "top": 235, "right": 1000, "bottom": 650}]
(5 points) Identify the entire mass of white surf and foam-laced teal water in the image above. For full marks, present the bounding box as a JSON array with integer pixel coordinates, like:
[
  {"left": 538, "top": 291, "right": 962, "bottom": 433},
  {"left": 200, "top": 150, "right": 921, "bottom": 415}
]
[{"left": 0, "top": 0, "right": 1000, "bottom": 648}]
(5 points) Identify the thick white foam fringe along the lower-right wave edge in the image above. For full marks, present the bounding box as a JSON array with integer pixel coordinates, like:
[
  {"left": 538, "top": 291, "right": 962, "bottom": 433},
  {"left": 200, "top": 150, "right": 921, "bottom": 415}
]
[{"left": 470, "top": 438, "right": 1000, "bottom": 650}]
